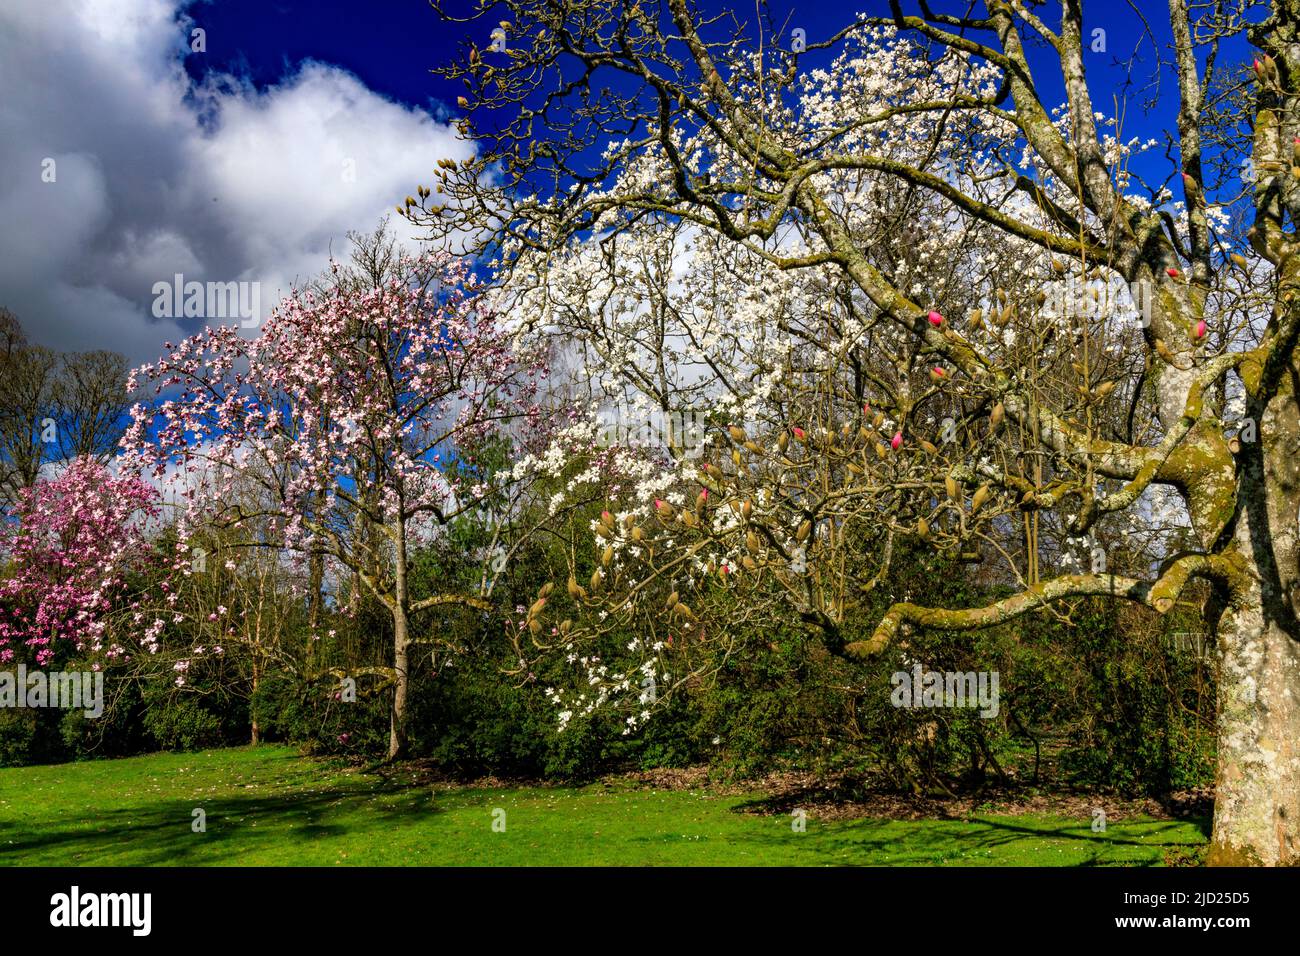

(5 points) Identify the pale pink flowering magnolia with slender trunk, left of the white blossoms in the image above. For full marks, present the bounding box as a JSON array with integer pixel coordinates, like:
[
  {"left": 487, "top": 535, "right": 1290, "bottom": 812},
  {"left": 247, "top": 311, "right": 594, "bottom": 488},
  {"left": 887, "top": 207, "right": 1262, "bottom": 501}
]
[{"left": 124, "top": 254, "right": 545, "bottom": 757}]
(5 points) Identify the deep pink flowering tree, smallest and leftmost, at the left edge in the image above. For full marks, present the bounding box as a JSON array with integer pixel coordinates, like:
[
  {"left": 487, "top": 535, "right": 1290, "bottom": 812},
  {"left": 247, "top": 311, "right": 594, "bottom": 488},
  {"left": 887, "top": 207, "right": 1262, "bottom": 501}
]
[{"left": 0, "top": 458, "right": 164, "bottom": 669}]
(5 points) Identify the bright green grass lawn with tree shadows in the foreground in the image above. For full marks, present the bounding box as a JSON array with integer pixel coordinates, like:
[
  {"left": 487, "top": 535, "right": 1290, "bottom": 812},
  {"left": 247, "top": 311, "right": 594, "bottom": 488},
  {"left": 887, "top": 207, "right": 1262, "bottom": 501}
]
[{"left": 0, "top": 747, "right": 1205, "bottom": 866}]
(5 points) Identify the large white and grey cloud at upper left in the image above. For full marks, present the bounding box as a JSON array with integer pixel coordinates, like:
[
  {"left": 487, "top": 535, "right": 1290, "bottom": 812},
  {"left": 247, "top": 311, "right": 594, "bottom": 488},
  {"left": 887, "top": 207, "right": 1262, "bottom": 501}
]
[{"left": 0, "top": 0, "right": 471, "bottom": 362}]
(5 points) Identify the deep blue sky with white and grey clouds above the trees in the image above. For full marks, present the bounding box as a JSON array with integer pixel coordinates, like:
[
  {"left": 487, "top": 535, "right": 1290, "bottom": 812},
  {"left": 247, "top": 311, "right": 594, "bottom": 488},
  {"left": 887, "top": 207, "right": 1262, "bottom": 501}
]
[{"left": 0, "top": 0, "right": 1249, "bottom": 362}]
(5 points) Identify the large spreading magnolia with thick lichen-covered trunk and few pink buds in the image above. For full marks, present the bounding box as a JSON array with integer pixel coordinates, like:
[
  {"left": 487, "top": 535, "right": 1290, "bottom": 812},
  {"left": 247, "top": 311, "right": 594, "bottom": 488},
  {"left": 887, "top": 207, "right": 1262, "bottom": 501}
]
[{"left": 407, "top": 0, "right": 1300, "bottom": 864}]
